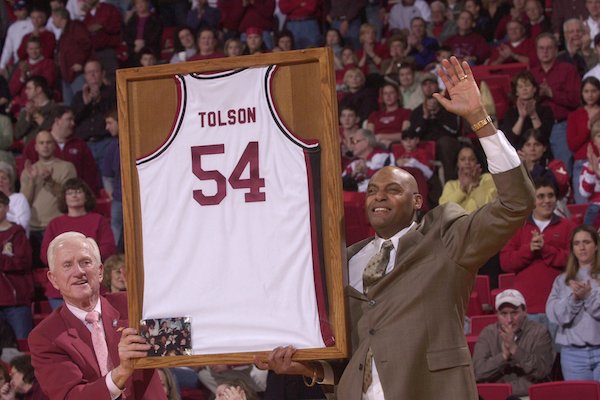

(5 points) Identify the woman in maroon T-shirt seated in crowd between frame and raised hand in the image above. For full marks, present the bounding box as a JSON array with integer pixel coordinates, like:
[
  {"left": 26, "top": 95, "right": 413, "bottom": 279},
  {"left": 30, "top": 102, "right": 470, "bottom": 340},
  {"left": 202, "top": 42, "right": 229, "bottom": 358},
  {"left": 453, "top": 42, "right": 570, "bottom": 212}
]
[{"left": 367, "top": 83, "right": 410, "bottom": 148}]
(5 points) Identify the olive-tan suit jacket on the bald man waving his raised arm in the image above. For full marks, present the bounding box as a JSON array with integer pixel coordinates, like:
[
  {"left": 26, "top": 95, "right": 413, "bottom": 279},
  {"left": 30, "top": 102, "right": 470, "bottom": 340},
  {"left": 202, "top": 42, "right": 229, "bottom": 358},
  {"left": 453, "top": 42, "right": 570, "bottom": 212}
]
[{"left": 337, "top": 163, "right": 534, "bottom": 400}]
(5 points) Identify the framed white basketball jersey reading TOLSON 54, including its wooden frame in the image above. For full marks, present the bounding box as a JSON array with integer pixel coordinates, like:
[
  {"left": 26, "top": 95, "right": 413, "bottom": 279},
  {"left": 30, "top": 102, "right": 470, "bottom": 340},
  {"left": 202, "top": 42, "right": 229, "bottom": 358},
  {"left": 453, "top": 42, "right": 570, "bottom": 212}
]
[{"left": 117, "top": 49, "right": 348, "bottom": 368}]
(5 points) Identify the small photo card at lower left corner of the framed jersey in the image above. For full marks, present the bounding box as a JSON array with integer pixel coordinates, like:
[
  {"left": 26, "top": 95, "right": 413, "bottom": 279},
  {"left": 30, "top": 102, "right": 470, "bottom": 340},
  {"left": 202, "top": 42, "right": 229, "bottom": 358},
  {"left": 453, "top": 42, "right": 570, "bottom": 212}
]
[{"left": 140, "top": 317, "right": 192, "bottom": 357}]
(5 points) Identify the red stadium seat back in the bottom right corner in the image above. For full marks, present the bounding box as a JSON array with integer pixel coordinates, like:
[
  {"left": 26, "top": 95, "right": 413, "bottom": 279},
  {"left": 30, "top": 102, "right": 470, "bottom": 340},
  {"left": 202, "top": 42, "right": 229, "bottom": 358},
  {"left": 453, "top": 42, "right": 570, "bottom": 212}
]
[{"left": 529, "top": 381, "right": 600, "bottom": 400}]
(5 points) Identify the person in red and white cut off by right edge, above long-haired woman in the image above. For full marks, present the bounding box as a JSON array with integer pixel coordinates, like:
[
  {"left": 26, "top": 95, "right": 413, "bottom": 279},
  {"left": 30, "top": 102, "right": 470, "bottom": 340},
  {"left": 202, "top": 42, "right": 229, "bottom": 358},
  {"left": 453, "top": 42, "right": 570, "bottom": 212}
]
[{"left": 579, "top": 120, "right": 600, "bottom": 226}]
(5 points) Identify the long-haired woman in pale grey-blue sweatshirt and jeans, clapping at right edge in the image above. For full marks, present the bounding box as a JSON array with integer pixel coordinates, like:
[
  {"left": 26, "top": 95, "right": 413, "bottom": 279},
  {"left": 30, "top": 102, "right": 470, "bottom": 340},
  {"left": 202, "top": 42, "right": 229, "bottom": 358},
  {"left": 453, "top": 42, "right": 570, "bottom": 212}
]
[{"left": 546, "top": 225, "right": 600, "bottom": 381}]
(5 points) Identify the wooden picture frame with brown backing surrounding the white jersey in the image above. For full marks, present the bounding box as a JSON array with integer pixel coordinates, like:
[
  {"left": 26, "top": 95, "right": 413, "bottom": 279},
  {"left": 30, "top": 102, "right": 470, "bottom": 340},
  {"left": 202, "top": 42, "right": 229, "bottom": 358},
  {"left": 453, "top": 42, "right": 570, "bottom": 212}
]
[{"left": 117, "top": 48, "right": 349, "bottom": 368}]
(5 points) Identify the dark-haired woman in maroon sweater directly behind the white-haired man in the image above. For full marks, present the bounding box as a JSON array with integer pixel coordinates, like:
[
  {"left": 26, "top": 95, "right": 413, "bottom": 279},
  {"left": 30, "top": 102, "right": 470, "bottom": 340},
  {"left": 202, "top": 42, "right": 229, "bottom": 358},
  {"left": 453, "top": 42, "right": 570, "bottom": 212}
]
[{"left": 40, "top": 178, "right": 117, "bottom": 308}]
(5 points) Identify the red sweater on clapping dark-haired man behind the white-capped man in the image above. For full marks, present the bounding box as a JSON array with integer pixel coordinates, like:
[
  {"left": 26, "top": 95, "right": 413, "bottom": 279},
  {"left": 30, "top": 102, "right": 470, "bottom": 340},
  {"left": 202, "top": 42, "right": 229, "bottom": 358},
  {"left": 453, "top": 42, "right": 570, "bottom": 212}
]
[{"left": 500, "top": 215, "right": 575, "bottom": 314}]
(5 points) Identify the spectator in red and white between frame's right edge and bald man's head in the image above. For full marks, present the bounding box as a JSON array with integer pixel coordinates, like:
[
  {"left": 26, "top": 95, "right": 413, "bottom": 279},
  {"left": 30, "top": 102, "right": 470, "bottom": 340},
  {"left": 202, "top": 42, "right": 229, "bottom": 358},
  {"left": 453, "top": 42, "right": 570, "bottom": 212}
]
[{"left": 342, "top": 129, "right": 394, "bottom": 192}]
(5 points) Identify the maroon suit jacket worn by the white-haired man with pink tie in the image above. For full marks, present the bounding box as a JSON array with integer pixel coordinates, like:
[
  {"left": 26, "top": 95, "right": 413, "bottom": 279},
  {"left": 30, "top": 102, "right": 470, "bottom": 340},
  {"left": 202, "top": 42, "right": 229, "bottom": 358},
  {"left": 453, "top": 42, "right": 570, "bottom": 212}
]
[{"left": 29, "top": 293, "right": 166, "bottom": 400}]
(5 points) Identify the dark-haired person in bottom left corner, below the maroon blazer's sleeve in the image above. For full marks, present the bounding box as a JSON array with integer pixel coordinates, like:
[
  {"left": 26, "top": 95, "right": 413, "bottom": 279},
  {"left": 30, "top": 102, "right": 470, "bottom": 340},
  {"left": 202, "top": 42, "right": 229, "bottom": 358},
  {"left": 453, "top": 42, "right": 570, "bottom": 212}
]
[{"left": 0, "top": 355, "right": 48, "bottom": 400}]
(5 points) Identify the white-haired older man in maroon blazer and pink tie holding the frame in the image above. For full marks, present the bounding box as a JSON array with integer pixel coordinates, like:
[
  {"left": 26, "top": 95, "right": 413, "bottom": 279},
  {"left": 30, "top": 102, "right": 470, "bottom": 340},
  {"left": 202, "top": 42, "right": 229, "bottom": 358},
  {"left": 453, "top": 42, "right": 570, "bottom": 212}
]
[{"left": 29, "top": 232, "right": 166, "bottom": 400}]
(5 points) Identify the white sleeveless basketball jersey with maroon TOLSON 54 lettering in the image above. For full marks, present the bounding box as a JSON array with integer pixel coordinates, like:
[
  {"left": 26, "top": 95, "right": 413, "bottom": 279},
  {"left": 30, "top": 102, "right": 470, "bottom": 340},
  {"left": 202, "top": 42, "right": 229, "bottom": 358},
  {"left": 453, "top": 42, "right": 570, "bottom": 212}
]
[{"left": 137, "top": 66, "right": 333, "bottom": 354}]
